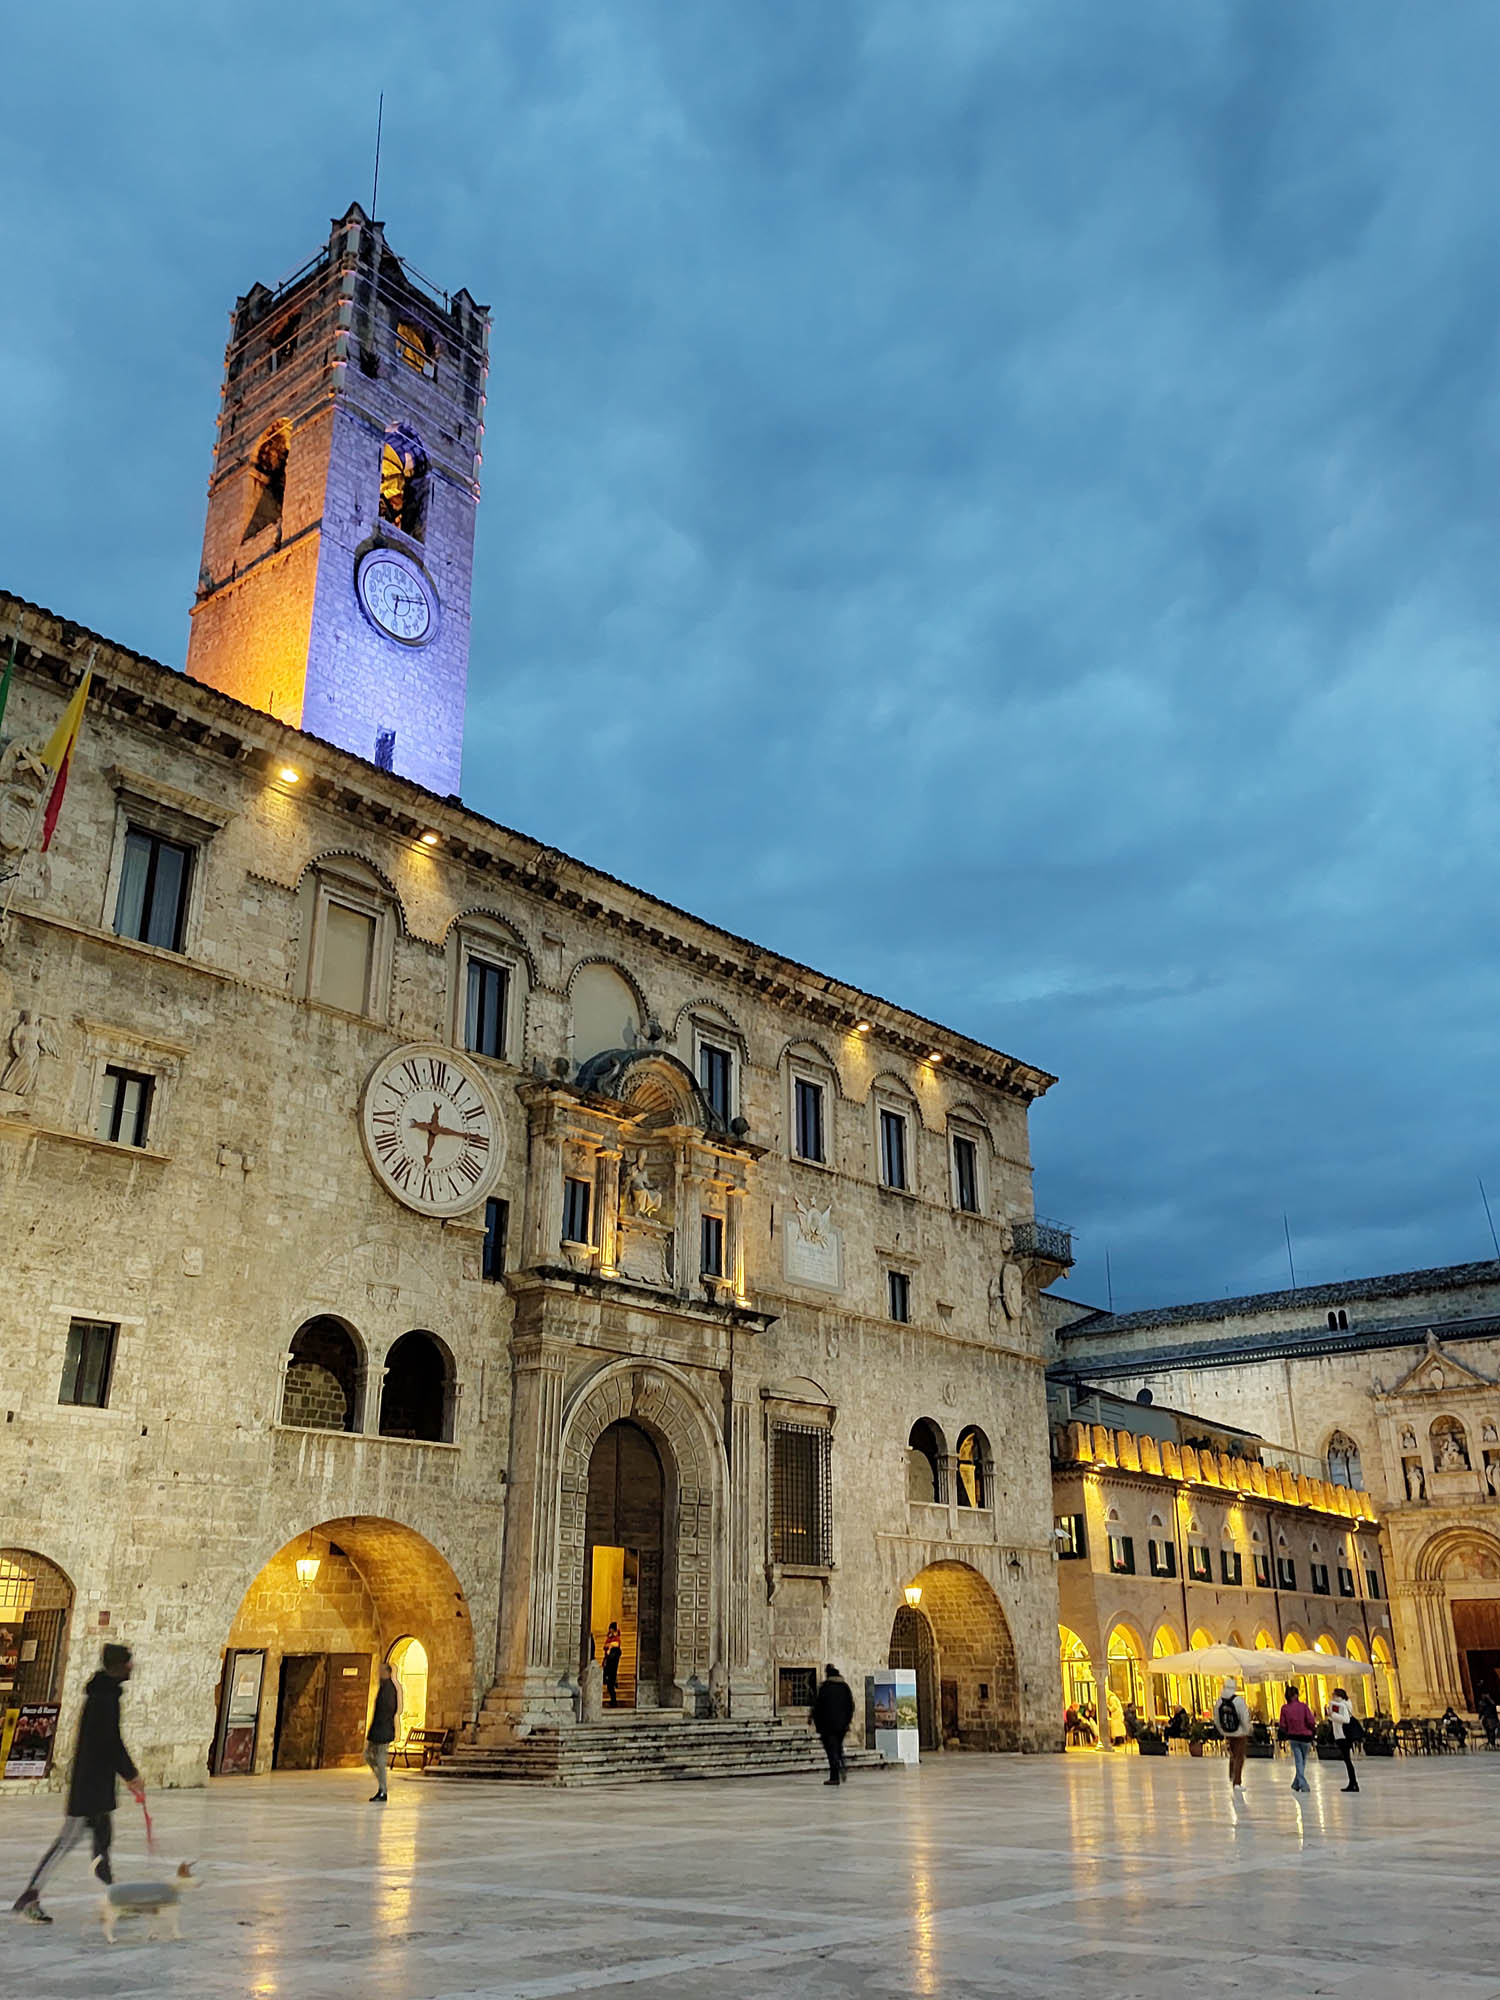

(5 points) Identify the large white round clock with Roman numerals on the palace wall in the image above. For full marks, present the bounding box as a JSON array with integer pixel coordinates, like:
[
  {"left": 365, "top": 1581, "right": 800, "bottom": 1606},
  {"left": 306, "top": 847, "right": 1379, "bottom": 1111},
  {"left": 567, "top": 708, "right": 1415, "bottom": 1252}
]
[{"left": 360, "top": 1042, "right": 502, "bottom": 1216}]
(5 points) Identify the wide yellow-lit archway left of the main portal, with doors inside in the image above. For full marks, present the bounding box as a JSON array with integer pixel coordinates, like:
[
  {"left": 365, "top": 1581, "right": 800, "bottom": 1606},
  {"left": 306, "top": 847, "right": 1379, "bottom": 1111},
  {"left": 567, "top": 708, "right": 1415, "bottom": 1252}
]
[{"left": 208, "top": 1514, "right": 474, "bottom": 1774}]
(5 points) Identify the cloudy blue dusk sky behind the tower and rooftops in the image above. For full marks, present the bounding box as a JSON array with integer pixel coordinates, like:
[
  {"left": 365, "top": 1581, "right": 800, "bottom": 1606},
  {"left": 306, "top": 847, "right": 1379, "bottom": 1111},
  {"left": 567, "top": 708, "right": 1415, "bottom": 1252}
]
[{"left": 0, "top": 0, "right": 1500, "bottom": 1308}]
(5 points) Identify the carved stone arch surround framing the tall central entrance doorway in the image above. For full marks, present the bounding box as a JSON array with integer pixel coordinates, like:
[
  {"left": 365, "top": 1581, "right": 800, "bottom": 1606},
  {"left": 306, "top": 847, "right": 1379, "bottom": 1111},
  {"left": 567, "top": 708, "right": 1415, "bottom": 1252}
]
[{"left": 548, "top": 1360, "right": 728, "bottom": 1706}]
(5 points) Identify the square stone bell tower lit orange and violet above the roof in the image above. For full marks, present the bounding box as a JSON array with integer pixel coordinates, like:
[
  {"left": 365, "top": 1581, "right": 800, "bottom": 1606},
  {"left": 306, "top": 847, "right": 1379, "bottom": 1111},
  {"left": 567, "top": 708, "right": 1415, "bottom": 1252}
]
[{"left": 188, "top": 202, "right": 490, "bottom": 794}]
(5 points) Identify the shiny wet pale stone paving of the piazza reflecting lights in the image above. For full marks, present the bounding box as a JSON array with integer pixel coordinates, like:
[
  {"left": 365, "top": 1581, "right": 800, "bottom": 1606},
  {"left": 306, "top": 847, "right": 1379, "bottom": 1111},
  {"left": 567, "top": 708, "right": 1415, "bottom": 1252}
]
[{"left": 0, "top": 1754, "right": 1500, "bottom": 2000}]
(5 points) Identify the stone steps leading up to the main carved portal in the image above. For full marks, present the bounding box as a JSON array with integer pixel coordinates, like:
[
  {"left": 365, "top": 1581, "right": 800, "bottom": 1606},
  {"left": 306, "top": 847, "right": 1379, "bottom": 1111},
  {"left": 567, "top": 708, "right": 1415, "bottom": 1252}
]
[{"left": 426, "top": 1710, "right": 890, "bottom": 1784}]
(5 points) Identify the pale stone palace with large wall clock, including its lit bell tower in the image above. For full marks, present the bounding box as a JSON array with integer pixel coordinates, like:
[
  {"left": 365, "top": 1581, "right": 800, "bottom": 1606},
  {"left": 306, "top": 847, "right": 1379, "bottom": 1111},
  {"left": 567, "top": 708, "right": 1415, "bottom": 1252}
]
[{"left": 0, "top": 208, "right": 1068, "bottom": 1784}]
